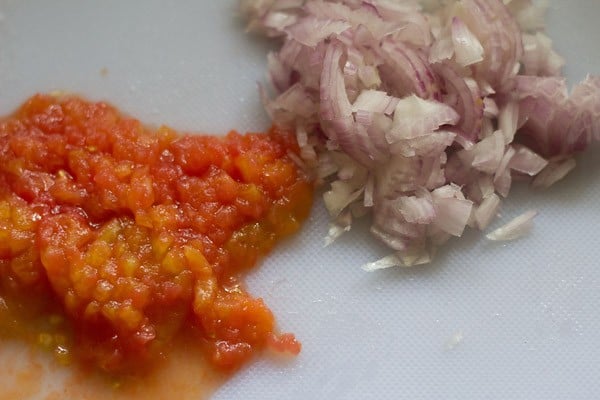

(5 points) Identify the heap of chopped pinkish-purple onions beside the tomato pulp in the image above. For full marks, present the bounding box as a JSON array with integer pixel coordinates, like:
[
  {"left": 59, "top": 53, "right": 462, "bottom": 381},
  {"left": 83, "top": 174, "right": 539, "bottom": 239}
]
[{"left": 242, "top": 0, "right": 600, "bottom": 270}]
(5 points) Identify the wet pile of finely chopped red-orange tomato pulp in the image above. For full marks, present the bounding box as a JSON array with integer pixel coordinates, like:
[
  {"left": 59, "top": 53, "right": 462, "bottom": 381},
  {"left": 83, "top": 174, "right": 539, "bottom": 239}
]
[{"left": 0, "top": 95, "right": 312, "bottom": 374}]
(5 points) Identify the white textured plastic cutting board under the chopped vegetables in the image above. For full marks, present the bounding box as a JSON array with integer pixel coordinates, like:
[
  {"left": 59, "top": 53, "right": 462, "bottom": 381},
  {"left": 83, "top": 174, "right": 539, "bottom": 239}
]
[{"left": 0, "top": 0, "right": 600, "bottom": 400}]
